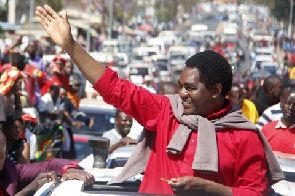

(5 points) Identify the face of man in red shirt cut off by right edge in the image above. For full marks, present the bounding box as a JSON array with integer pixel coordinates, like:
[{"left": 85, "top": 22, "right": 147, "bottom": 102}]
[{"left": 281, "top": 91, "right": 295, "bottom": 122}]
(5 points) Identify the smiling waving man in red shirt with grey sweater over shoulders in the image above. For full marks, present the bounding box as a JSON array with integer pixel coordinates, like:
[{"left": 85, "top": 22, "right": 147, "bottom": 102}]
[{"left": 36, "top": 5, "right": 284, "bottom": 195}]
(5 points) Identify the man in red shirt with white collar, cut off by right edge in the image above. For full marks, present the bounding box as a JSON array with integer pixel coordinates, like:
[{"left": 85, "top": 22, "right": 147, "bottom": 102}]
[{"left": 262, "top": 87, "right": 295, "bottom": 155}]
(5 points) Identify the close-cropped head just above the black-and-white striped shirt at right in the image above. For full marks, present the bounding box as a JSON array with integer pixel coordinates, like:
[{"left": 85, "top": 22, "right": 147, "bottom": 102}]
[{"left": 263, "top": 75, "right": 282, "bottom": 104}]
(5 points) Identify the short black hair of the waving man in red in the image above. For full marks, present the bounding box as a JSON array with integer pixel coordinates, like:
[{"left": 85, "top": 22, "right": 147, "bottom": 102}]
[{"left": 185, "top": 50, "right": 233, "bottom": 96}]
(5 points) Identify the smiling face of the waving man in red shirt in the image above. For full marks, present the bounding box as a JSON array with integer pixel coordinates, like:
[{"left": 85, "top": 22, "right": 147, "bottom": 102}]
[{"left": 178, "top": 68, "right": 212, "bottom": 116}]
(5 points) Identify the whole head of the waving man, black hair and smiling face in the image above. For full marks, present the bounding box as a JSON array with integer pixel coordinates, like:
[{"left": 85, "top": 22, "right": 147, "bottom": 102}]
[{"left": 178, "top": 50, "right": 232, "bottom": 116}]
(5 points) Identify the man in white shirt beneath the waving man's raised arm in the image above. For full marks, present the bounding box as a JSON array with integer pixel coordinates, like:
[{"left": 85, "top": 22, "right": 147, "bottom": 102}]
[{"left": 103, "top": 110, "right": 137, "bottom": 154}]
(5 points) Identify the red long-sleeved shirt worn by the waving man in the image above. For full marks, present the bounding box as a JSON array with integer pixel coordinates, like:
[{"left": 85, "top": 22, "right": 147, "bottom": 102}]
[{"left": 94, "top": 69, "right": 267, "bottom": 196}]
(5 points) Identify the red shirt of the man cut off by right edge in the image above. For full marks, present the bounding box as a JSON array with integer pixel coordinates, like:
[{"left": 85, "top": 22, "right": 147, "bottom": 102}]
[{"left": 262, "top": 121, "right": 295, "bottom": 155}]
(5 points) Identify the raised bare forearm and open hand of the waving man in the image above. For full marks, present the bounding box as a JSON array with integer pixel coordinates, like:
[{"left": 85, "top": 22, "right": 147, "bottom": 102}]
[{"left": 35, "top": 5, "right": 105, "bottom": 84}]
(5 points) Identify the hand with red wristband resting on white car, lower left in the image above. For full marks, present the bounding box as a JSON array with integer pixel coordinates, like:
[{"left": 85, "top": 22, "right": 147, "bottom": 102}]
[{"left": 61, "top": 169, "right": 95, "bottom": 186}]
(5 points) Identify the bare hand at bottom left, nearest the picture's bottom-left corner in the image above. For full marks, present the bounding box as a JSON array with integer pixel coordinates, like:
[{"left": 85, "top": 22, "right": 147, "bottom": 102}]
[{"left": 16, "top": 171, "right": 57, "bottom": 196}]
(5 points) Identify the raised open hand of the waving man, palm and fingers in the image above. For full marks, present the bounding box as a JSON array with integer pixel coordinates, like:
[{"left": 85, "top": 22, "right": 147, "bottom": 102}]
[{"left": 35, "top": 5, "right": 74, "bottom": 50}]
